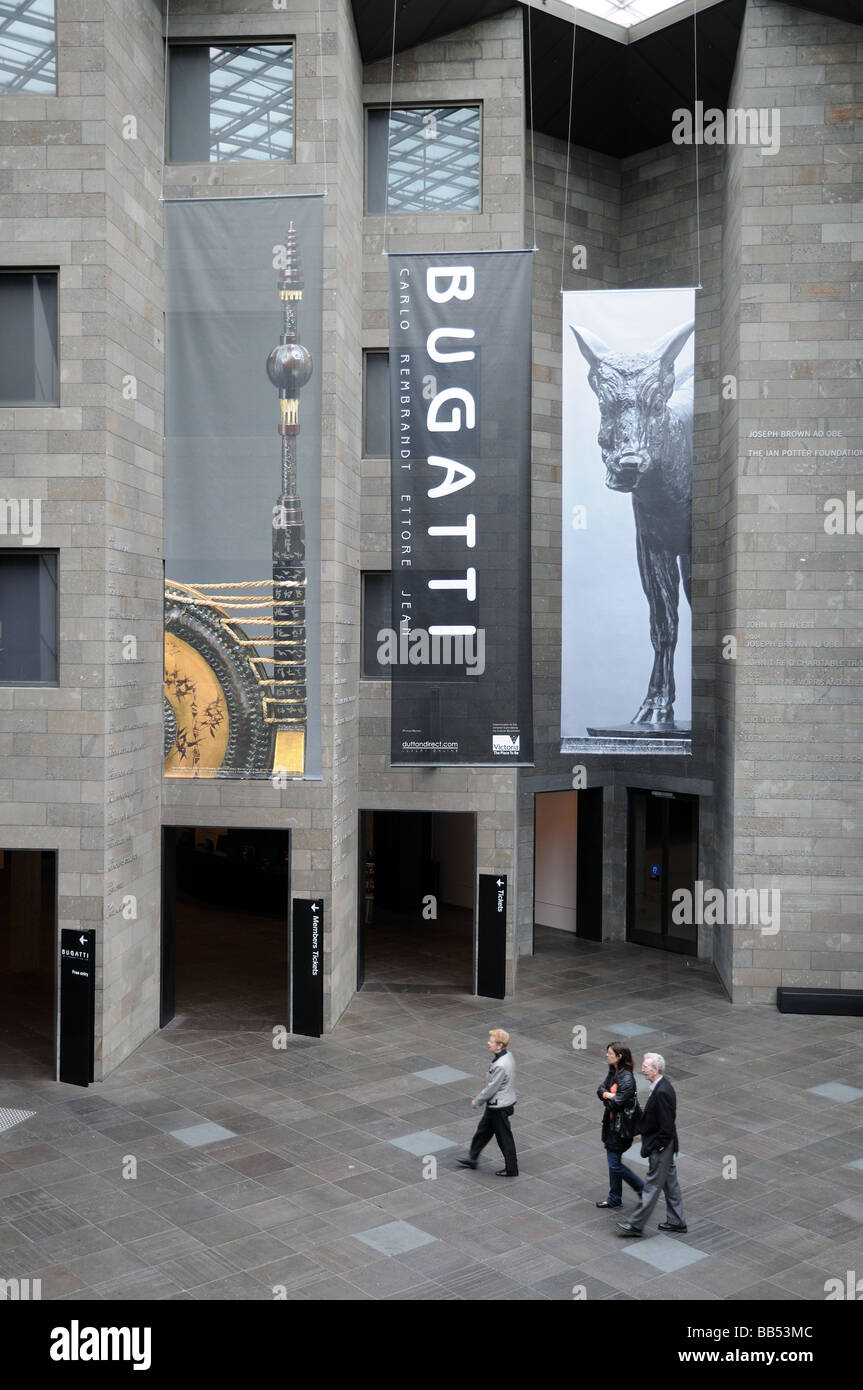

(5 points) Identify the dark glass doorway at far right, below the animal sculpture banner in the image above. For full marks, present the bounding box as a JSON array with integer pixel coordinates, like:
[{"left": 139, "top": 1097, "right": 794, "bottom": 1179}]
[{"left": 627, "top": 790, "right": 698, "bottom": 955}]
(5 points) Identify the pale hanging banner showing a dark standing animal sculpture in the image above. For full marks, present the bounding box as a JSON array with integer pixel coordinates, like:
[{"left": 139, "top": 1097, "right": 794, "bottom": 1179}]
[{"left": 560, "top": 289, "right": 695, "bottom": 753}]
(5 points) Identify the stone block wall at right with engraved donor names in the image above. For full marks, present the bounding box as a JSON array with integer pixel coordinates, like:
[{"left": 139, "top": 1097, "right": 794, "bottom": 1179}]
[{"left": 721, "top": 0, "right": 863, "bottom": 1001}]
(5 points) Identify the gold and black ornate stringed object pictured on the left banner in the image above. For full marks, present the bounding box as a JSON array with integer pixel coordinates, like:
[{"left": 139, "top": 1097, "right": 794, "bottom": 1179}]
[{"left": 164, "top": 222, "right": 313, "bottom": 777}]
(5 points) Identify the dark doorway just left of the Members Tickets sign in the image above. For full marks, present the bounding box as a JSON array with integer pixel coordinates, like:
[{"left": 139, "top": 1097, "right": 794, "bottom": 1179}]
[{"left": 161, "top": 826, "right": 290, "bottom": 1031}]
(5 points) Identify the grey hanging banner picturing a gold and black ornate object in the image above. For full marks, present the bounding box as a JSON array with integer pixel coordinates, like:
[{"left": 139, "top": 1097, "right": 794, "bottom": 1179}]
[{"left": 164, "top": 197, "right": 322, "bottom": 778}]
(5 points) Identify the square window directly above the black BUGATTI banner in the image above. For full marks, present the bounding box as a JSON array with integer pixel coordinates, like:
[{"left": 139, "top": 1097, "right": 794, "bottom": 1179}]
[{"left": 367, "top": 106, "right": 479, "bottom": 213}]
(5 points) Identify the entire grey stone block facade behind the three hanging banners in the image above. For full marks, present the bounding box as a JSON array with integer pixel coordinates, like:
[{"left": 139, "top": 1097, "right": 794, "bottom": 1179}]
[{"left": 0, "top": 0, "right": 863, "bottom": 1079}]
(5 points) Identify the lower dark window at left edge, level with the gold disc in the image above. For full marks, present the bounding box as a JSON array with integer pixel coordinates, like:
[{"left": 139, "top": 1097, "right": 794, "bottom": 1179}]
[{"left": 0, "top": 553, "right": 57, "bottom": 685}]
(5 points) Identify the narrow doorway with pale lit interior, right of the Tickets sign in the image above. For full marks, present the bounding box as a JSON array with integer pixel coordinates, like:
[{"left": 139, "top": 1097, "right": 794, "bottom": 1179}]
[{"left": 534, "top": 787, "right": 602, "bottom": 949}]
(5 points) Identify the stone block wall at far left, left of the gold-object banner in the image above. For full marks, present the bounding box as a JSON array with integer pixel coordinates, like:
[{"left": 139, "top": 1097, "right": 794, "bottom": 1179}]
[{"left": 0, "top": 0, "right": 163, "bottom": 1077}]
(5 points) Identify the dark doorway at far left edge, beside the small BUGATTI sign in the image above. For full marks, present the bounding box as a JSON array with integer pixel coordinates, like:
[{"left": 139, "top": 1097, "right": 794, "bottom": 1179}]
[{"left": 0, "top": 849, "right": 57, "bottom": 1077}]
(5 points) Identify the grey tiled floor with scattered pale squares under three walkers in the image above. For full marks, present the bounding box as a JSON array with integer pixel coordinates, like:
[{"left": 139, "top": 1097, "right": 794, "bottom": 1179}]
[{"left": 0, "top": 931, "right": 863, "bottom": 1301}]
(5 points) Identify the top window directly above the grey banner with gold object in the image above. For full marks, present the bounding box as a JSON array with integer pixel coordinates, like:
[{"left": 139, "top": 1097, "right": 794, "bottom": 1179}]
[{"left": 168, "top": 43, "right": 293, "bottom": 164}]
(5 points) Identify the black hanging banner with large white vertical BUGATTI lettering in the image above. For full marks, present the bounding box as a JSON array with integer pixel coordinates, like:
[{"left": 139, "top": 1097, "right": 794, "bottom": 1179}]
[{"left": 389, "top": 252, "right": 534, "bottom": 767}]
